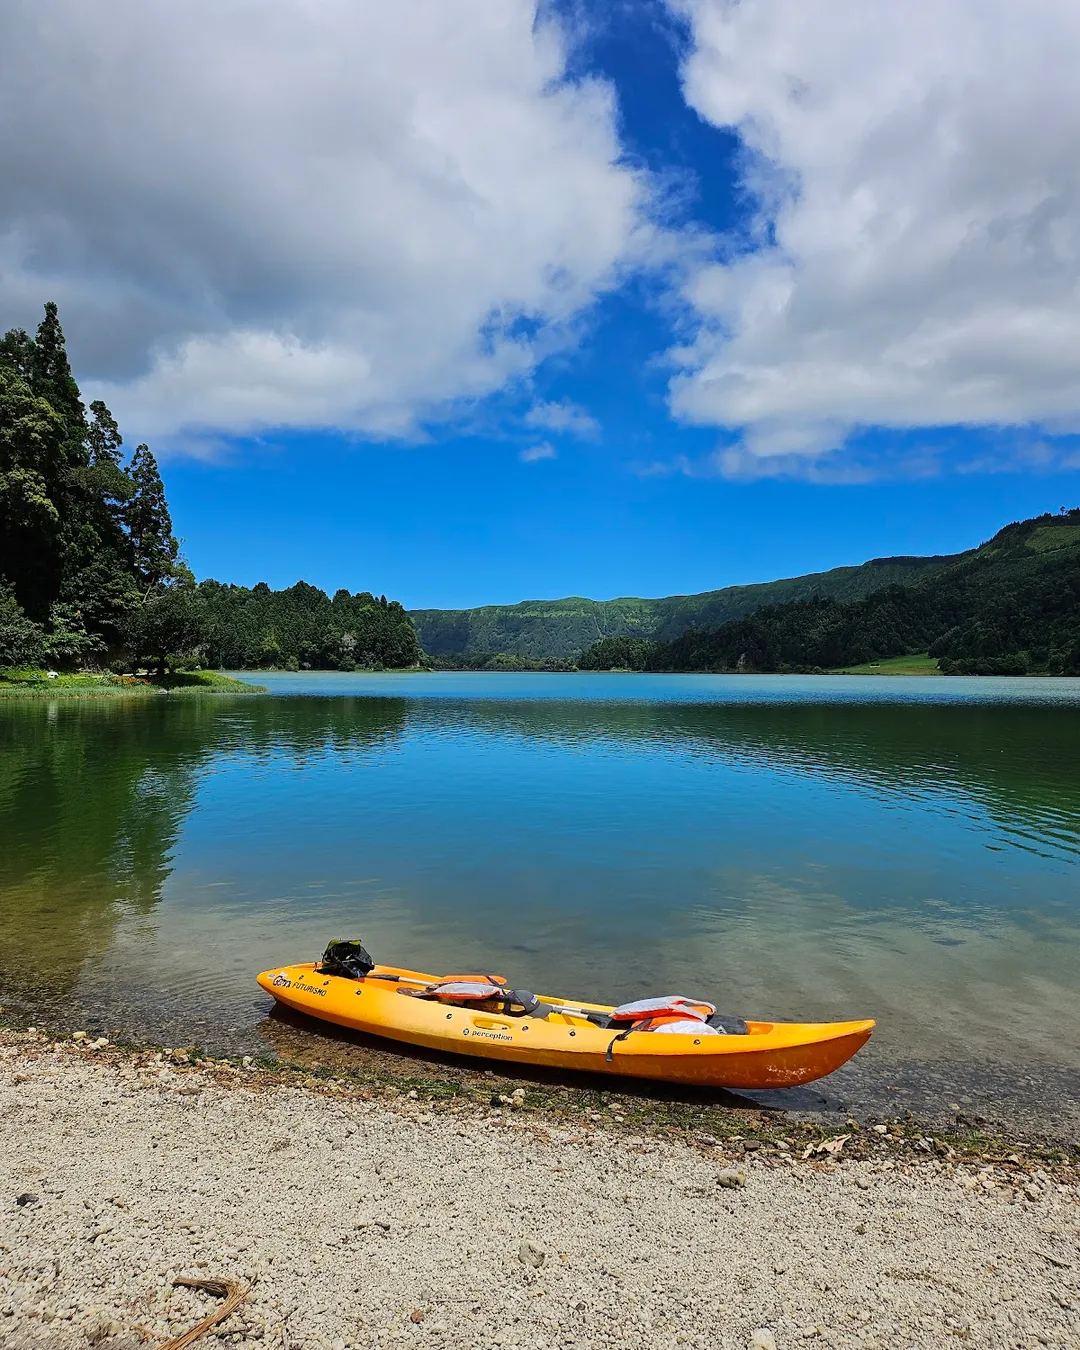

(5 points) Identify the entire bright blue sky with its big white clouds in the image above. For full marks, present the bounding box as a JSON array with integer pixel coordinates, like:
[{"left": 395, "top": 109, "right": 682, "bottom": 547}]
[{"left": 8, "top": 0, "right": 1080, "bottom": 608}]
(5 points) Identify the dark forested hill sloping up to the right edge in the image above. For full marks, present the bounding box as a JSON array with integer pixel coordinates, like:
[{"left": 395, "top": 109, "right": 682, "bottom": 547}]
[{"left": 581, "top": 509, "right": 1080, "bottom": 675}]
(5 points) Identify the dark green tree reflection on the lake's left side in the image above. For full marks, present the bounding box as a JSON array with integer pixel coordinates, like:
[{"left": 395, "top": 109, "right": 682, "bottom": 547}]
[{"left": 0, "top": 698, "right": 404, "bottom": 1004}]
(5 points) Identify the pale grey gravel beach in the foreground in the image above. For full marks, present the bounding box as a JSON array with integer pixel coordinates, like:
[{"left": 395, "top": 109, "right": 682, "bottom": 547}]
[{"left": 0, "top": 1035, "right": 1080, "bottom": 1350}]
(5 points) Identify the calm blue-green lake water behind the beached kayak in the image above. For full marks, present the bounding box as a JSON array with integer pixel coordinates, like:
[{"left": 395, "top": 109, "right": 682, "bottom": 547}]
[{"left": 0, "top": 674, "right": 1080, "bottom": 1127}]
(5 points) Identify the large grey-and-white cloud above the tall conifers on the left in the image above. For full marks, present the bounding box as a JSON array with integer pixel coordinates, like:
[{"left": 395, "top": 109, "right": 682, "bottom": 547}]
[{"left": 0, "top": 0, "right": 655, "bottom": 450}]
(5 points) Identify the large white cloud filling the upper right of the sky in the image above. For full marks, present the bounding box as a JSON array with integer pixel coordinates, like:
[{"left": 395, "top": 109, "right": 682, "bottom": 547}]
[{"left": 670, "top": 0, "right": 1080, "bottom": 473}]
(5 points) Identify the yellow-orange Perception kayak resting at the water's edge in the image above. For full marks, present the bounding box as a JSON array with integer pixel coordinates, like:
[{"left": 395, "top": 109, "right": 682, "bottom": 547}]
[{"left": 258, "top": 961, "right": 875, "bottom": 1088}]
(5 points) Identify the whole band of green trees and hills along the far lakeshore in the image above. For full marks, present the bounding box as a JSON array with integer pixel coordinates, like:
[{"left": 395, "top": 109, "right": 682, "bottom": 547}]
[{"left": 0, "top": 304, "right": 1080, "bottom": 694}]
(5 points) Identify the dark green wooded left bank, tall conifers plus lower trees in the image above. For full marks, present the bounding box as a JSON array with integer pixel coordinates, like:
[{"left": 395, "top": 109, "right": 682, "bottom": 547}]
[{"left": 0, "top": 304, "right": 420, "bottom": 674}]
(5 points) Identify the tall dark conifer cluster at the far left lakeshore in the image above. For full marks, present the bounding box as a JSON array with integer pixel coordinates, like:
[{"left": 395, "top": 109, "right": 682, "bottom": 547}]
[{"left": 0, "top": 304, "right": 180, "bottom": 666}]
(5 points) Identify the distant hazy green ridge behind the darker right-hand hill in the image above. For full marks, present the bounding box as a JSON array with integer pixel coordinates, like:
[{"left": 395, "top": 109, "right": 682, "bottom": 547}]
[{"left": 409, "top": 555, "right": 963, "bottom": 659}]
